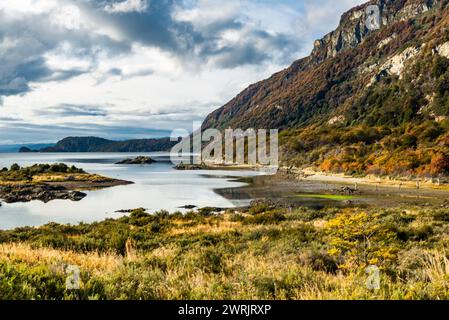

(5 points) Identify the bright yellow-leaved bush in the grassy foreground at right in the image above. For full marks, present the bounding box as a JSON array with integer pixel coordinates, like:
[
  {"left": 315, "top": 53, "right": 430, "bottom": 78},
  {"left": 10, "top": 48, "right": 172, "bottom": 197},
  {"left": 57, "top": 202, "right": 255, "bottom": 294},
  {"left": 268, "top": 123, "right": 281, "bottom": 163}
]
[{"left": 326, "top": 212, "right": 397, "bottom": 271}]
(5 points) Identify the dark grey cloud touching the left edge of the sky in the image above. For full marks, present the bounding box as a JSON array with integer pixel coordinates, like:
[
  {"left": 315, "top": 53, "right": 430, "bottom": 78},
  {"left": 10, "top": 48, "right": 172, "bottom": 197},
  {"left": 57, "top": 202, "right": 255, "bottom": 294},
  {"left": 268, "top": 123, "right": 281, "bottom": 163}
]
[{"left": 0, "top": 5, "right": 130, "bottom": 96}]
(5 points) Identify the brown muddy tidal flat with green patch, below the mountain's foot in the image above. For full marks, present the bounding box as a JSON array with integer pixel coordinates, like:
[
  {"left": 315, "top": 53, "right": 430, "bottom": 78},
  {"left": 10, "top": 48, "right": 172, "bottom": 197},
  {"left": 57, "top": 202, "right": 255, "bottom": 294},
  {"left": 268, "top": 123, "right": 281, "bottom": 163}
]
[{"left": 215, "top": 172, "right": 449, "bottom": 208}]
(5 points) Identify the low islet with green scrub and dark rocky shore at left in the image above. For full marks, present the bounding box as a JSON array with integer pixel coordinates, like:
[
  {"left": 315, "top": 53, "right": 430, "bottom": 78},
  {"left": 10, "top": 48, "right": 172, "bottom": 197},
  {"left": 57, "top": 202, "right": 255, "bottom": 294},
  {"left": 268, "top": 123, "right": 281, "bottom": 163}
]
[{"left": 0, "top": 163, "right": 132, "bottom": 203}]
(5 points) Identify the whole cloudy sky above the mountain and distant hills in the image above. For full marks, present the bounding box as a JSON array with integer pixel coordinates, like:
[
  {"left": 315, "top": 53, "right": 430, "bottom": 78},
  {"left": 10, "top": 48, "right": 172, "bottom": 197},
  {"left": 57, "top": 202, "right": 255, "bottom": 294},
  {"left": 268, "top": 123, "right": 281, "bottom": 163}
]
[{"left": 0, "top": 0, "right": 365, "bottom": 144}]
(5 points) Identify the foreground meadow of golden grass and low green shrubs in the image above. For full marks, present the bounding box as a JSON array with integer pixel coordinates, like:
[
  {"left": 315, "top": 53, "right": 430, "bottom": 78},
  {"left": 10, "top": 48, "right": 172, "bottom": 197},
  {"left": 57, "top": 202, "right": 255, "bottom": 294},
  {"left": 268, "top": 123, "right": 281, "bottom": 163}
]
[{"left": 0, "top": 204, "right": 449, "bottom": 299}]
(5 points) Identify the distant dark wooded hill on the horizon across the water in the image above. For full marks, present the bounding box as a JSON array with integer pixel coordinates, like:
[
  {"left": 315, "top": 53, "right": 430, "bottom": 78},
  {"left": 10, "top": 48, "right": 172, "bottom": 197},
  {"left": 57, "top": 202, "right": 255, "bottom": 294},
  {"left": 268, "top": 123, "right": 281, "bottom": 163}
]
[{"left": 20, "top": 137, "right": 177, "bottom": 152}]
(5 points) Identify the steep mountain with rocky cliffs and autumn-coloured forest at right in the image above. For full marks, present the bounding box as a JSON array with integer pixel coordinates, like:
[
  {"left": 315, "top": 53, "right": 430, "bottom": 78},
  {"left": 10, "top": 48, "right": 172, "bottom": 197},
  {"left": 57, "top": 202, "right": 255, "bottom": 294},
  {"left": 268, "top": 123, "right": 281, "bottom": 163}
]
[{"left": 202, "top": 0, "right": 449, "bottom": 176}]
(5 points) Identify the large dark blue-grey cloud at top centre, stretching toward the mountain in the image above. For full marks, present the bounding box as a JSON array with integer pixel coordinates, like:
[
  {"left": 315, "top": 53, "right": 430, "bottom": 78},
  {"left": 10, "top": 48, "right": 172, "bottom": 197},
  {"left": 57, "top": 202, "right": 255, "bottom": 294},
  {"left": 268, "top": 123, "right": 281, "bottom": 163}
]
[{"left": 97, "top": 0, "right": 300, "bottom": 68}]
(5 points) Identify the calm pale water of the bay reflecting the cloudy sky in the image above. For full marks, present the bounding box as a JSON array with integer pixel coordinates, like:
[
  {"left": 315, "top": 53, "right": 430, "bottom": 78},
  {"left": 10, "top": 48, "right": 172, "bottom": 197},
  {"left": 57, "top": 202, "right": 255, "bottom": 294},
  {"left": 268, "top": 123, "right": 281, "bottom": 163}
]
[{"left": 0, "top": 153, "right": 260, "bottom": 229}]
